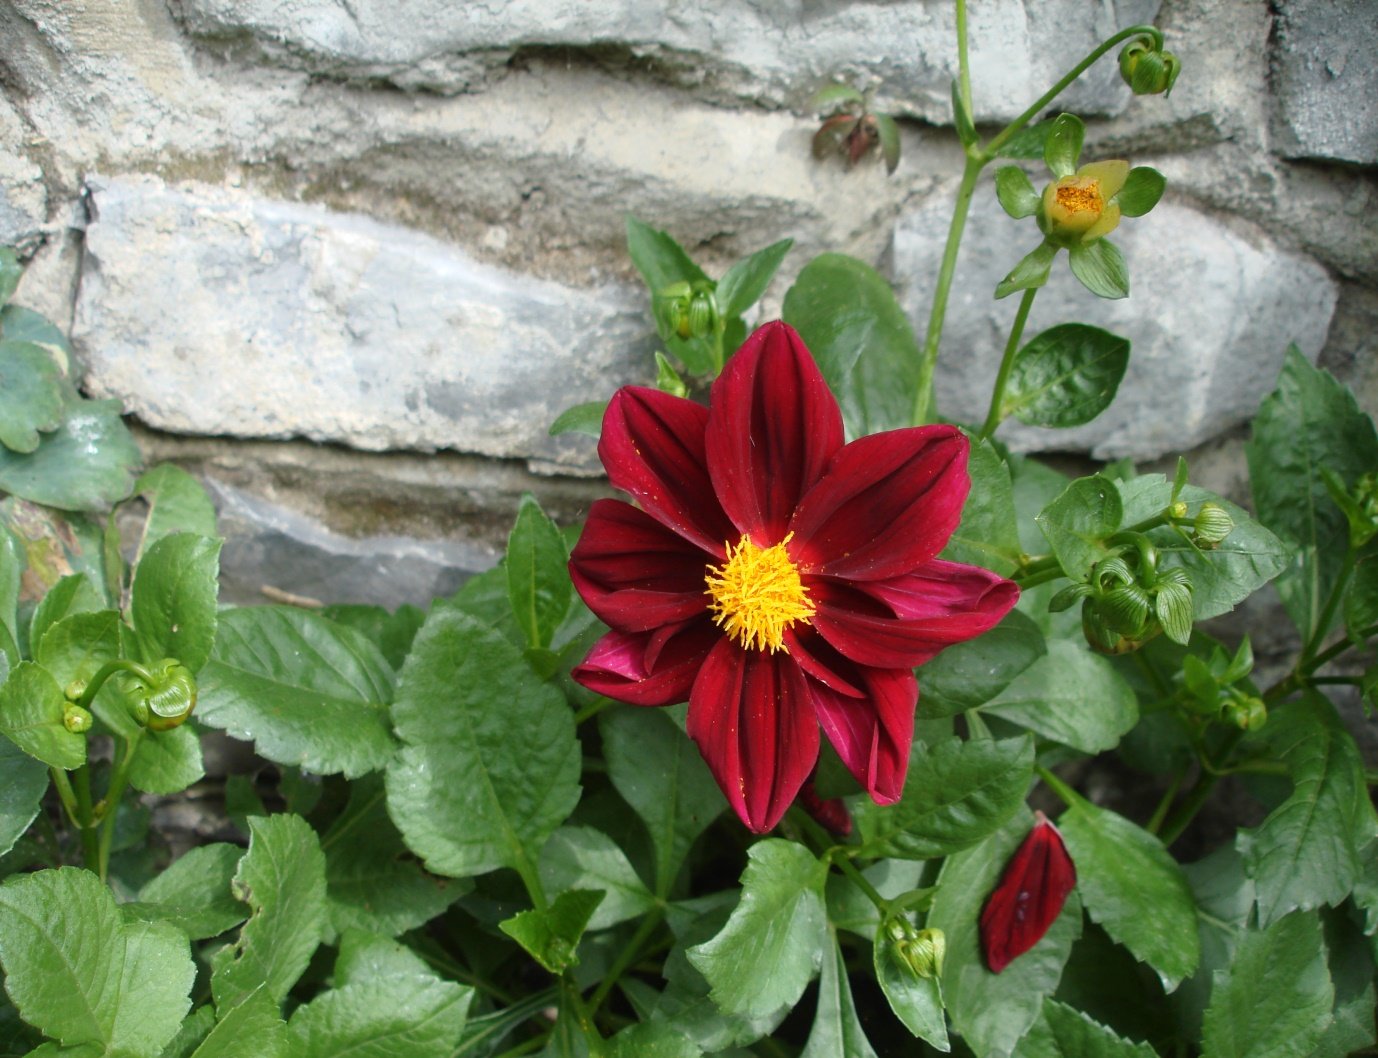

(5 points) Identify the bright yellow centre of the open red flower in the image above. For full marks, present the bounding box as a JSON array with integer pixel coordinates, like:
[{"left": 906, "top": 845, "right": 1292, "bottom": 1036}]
[{"left": 704, "top": 533, "right": 813, "bottom": 653}]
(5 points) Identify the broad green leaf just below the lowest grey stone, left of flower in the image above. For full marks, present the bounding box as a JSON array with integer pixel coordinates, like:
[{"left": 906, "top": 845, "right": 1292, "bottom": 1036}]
[{"left": 196, "top": 606, "right": 395, "bottom": 778}]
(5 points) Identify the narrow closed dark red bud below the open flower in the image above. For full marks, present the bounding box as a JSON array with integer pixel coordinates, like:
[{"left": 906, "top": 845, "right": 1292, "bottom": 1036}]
[{"left": 981, "top": 811, "right": 1076, "bottom": 974}]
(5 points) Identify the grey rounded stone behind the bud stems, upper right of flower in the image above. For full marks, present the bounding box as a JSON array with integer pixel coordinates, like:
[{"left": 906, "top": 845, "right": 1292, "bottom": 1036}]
[{"left": 893, "top": 189, "right": 1337, "bottom": 459}]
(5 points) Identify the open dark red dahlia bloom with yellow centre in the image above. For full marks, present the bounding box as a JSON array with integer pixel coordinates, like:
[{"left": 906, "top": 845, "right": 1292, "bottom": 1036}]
[{"left": 569, "top": 322, "right": 1018, "bottom": 832}]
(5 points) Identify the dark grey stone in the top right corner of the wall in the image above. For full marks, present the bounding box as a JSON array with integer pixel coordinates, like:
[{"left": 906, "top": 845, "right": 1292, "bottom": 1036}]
[{"left": 1273, "top": 0, "right": 1378, "bottom": 165}]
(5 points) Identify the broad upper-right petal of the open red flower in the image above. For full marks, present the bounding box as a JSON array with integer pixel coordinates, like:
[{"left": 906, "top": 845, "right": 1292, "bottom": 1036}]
[{"left": 790, "top": 426, "right": 971, "bottom": 580}]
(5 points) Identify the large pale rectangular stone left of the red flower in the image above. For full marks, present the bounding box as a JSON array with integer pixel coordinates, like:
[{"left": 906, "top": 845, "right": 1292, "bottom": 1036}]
[{"left": 73, "top": 178, "right": 650, "bottom": 471}]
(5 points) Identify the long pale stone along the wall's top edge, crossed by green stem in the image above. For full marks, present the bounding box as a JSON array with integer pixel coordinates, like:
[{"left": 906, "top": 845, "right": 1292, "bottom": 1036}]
[{"left": 178, "top": 0, "right": 1158, "bottom": 123}]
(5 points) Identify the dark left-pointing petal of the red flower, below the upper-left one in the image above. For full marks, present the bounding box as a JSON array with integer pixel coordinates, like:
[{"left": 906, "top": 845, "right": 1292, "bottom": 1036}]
[{"left": 569, "top": 500, "right": 722, "bottom": 632}]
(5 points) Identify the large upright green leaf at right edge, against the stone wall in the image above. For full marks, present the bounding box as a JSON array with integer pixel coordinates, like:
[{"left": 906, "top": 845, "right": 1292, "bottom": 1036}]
[{"left": 1251, "top": 346, "right": 1378, "bottom": 642}]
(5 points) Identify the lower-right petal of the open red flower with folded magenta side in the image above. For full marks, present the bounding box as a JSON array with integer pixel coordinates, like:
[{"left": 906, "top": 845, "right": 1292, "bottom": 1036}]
[{"left": 813, "top": 665, "right": 919, "bottom": 805}]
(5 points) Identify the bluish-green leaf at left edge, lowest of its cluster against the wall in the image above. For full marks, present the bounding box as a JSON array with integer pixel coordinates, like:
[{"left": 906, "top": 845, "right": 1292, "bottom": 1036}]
[{"left": 0, "top": 400, "right": 139, "bottom": 511}]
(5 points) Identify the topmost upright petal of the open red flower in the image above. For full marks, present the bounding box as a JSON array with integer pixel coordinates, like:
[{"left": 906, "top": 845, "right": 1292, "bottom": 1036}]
[{"left": 707, "top": 322, "right": 843, "bottom": 547}]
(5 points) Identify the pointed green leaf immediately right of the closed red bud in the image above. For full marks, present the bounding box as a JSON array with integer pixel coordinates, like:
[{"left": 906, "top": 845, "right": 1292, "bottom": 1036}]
[{"left": 1057, "top": 799, "right": 1202, "bottom": 992}]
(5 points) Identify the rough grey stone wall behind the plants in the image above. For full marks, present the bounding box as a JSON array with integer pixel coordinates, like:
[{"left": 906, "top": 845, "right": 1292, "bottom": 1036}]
[{"left": 0, "top": 0, "right": 1378, "bottom": 605}]
